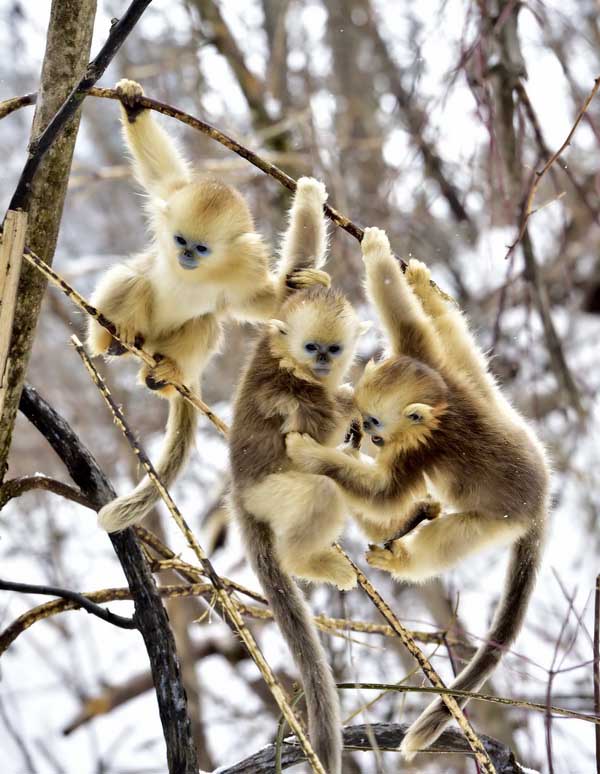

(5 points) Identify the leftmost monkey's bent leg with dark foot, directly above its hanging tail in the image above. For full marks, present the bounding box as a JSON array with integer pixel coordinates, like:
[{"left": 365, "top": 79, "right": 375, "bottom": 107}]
[{"left": 138, "top": 314, "right": 221, "bottom": 399}]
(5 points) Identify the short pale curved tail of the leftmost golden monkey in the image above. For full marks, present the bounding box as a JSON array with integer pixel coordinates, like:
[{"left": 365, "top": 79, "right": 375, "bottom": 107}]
[{"left": 98, "top": 395, "right": 198, "bottom": 532}]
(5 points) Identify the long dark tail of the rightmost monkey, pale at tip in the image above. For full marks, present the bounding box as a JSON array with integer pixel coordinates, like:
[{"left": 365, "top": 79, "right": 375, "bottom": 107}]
[{"left": 400, "top": 517, "right": 545, "bottom": 761}]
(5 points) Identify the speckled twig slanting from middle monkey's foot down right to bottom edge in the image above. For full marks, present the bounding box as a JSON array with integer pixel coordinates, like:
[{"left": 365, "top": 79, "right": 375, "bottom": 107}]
[{"left": 336, "top": 546, "right": 496, "bottom": 774}]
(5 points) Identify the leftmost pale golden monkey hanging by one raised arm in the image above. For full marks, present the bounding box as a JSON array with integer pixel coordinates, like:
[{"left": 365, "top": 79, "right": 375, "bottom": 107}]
[{"left": 88, "top": 80, "right": 329, "bottom": 532}]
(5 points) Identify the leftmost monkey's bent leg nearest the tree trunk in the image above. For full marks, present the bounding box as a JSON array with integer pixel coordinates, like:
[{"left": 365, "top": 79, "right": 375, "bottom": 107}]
[{"left": 87, "top": 260, "right": 153, "bottom": 355}]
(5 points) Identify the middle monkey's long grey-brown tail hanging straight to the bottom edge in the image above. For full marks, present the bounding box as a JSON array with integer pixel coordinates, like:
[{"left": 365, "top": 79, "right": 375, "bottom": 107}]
[{"left": 235, "top": 510, "right": 342, "bottom": 774}]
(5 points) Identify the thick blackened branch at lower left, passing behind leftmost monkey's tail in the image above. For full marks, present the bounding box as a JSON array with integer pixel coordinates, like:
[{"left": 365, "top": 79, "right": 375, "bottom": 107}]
[{"left": 19, "top": 385, "right": 198, "bottom": 774}]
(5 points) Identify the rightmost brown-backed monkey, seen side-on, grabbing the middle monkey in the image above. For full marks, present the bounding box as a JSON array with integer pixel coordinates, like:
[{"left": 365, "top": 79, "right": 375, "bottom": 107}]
[{"left": 287, "top": 228, "right": 550, "bottom": 760}]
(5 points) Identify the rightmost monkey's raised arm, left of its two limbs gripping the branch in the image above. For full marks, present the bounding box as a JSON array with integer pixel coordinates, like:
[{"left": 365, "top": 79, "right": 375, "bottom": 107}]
[{"left": 361, "top": 228, "right": 442, "bottom": 368}]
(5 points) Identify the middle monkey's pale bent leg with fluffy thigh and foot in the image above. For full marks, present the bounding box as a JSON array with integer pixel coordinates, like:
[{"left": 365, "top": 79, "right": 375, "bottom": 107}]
[{"left": 244, "top": 471, "right": 356, "bottom": 589}]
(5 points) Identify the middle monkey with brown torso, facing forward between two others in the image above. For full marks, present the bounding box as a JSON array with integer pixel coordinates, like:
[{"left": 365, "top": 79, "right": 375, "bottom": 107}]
[{"left": 230, "top": 181, "right": 368, "bottom": 774}]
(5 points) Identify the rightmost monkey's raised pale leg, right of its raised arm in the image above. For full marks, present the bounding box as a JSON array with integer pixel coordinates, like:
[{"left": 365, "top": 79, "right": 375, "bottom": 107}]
[{"left": 406, "top": 259, "right": 496, "bottom": 395}]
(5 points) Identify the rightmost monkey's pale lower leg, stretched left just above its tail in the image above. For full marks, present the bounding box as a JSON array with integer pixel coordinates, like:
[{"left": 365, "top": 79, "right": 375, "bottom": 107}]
[{"left": 367, "top": 511, "right": 527, "bottom": 581}]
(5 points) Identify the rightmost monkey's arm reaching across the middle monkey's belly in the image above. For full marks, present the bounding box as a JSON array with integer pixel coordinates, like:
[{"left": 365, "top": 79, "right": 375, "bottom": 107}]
[{"left": 286, "top": 433, "right": 426, "bottom": 519}]
